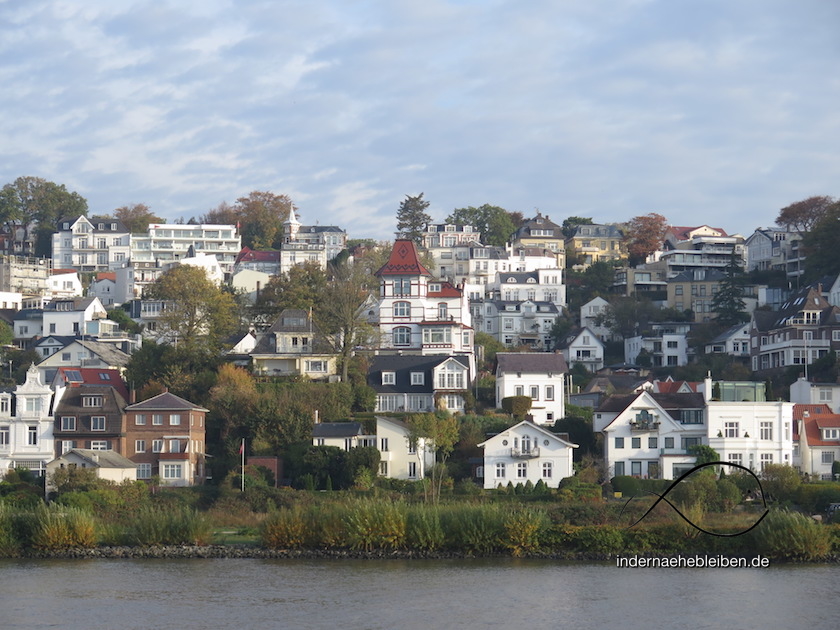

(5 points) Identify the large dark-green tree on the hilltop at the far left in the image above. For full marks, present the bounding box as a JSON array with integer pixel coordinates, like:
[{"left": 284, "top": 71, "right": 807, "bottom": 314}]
[{"left": 0, "top": 177, "right": 87, "bottom": 256}]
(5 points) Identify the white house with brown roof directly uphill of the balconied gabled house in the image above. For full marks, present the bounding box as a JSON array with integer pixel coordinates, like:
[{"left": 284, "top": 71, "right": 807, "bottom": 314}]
[{"left": 496, "top": 352, "right": 568, "bottom": 424}]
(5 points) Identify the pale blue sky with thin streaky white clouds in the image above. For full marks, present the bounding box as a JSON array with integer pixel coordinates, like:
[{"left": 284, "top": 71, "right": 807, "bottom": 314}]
[{"left": 0, "top": 0, "right": 840, "bottom": 239}]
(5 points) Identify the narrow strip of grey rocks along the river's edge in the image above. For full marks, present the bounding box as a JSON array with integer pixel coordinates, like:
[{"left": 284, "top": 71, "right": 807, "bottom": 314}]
[{"left": 11, "top": 545, "right": 840, "bottom": 564}]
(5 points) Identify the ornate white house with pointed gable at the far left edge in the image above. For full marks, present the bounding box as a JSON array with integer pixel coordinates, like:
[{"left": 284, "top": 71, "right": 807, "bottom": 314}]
[{"left": 0, "top": 365, "right": 55, "bottom": 475}]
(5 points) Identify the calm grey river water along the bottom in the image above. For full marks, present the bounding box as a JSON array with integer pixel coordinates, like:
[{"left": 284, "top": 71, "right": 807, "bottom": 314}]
[{"left": 0, "top": 559, "right": 840, "bottom": 630}]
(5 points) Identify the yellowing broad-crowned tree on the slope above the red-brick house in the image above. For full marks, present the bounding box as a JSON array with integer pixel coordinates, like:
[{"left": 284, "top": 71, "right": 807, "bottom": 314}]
[{"left": 147, "top": 265, "right": 237, "bottom": 353}]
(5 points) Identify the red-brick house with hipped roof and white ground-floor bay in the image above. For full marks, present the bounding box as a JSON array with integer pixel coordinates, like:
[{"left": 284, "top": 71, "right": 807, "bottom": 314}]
[{"left": 125, "top": 392, "right": 208, "bottom": 486}]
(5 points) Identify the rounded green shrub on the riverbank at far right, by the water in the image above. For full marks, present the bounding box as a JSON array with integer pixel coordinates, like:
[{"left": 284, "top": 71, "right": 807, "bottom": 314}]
[{"left": 753, "top": 510, "right": 831, "bottom": 561}]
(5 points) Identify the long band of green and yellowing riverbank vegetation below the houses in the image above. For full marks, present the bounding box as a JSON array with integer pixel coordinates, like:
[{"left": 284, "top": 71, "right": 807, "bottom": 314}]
[{"left": 0, "top": 472, "right": 840, "bottom": 561}]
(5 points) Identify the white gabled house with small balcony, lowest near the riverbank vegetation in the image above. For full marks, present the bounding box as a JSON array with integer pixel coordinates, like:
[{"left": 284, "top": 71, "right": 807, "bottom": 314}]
[{"left": 478, "top": 420, "right": 578, "bottom": 489}]
